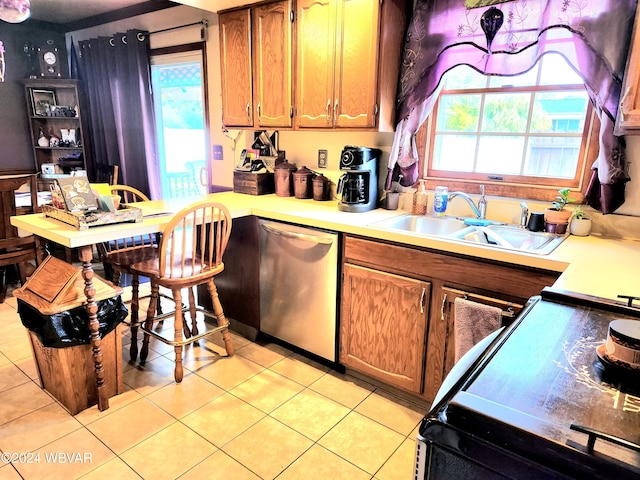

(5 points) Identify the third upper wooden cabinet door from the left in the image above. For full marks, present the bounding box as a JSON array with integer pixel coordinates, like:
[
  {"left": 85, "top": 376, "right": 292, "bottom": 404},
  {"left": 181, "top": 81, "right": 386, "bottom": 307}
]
[{"left": 296, "top": 0, "right": 336, "bottom": 128}]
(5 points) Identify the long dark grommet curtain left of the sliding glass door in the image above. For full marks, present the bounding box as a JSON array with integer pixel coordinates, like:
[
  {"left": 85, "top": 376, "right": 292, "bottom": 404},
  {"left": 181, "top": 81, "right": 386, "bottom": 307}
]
[{"left": 77, "top": 30, "right": 160, "bottom": 198}]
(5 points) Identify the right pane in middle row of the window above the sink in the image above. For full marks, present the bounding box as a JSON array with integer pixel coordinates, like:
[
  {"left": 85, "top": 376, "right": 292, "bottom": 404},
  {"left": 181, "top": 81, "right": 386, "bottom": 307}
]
[{"left": 531, "top": 92, "right": 589, "bottom": 134}]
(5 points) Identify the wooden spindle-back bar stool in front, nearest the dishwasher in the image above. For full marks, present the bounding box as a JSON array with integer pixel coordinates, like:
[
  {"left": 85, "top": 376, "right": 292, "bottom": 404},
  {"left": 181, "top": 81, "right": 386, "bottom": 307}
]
[{"left": 130, "top": 200, "right": 234, "bottom": 383}]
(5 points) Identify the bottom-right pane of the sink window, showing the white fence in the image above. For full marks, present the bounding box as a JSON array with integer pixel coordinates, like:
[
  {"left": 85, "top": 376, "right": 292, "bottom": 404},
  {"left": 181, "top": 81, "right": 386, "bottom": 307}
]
[{"left": 524, "top": 137, "right": 582, "bottom": 178}]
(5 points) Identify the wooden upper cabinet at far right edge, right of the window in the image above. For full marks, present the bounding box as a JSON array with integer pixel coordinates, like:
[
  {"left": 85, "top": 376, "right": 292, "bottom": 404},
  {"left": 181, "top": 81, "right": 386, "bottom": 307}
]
[{"left": 614, "top": 4, "right": 640, "bottom": 135}]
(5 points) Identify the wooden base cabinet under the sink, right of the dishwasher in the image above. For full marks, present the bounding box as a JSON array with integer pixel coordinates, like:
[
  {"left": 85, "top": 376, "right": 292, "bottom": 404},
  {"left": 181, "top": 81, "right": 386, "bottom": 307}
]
[{"left": 340, "top": 235, "right": 559, "bottom": 401}]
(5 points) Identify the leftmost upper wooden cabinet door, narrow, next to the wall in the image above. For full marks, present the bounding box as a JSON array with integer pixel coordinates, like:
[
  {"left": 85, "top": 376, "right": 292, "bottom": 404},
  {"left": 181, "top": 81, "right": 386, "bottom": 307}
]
[{"left": 219, "top": 8, "right": 253, "bottom": 127}]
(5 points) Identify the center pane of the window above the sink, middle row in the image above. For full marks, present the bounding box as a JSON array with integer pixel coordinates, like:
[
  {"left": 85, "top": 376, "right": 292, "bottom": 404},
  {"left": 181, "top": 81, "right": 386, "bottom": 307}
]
[{"left": 482, "top": 93, "right": 531, "bottom": 133}]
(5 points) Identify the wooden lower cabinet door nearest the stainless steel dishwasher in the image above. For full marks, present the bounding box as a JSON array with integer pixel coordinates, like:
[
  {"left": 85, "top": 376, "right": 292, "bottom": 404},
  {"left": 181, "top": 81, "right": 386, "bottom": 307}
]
[{"left": 340, "top": 264, "right": 431, "bottom": 393}]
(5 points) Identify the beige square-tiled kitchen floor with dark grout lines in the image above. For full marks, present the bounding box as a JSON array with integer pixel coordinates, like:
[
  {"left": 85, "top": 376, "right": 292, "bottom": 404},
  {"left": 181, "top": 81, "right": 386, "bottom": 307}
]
[{"left": 0, "top": 284, "right": 425, "bottom": 480}]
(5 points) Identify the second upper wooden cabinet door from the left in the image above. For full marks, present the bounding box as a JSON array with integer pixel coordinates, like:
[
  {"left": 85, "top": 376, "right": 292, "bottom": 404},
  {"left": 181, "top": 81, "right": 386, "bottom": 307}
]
[{"left": 253, "top": 1, "right": 292, "bottom": 127}]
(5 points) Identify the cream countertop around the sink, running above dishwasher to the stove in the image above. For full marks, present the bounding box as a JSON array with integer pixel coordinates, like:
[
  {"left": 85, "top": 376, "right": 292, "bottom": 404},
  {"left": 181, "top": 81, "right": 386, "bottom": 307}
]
[{"left": 212, "top": 192, "right": 640, "bottom": 300}]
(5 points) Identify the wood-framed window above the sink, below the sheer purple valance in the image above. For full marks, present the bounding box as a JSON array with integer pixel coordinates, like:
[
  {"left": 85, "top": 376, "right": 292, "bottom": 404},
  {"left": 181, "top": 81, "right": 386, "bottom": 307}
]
[{"left": 417, "top": 54, "right": 591, "bottom": 199}]
